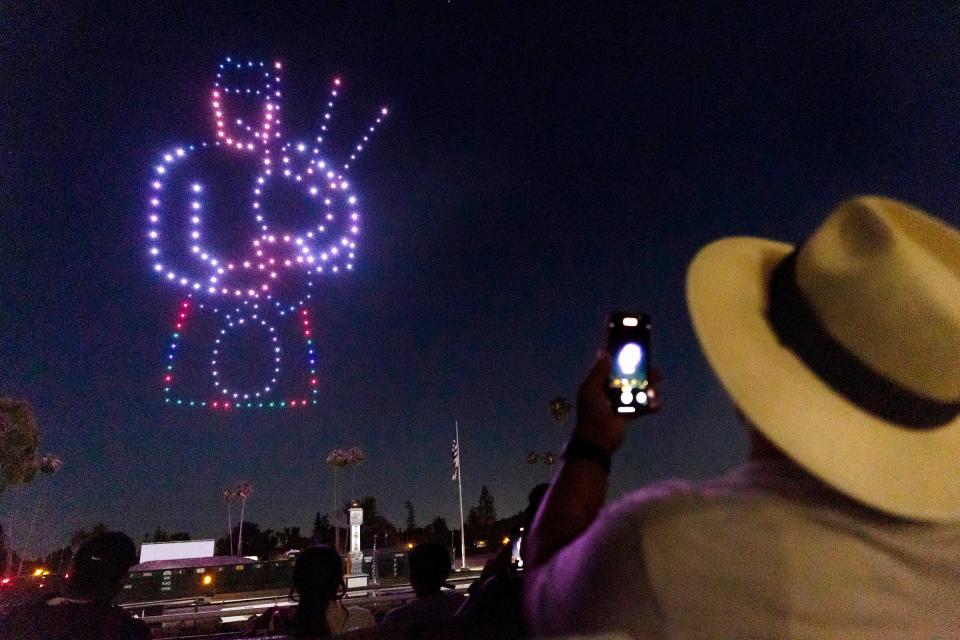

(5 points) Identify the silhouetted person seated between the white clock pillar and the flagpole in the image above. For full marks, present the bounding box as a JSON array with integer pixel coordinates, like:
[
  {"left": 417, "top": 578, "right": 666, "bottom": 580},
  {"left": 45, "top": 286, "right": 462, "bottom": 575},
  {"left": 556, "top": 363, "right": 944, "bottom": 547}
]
[{"left": 383, "top": 542, "right": 466, "bottom": 627}]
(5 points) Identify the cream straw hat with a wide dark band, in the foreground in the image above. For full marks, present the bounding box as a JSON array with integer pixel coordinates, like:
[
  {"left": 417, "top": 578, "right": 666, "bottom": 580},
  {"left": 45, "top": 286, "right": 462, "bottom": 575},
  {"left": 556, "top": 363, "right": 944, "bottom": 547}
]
[{"left": 687, "top": 196, "right": 960, "bottom": 522}]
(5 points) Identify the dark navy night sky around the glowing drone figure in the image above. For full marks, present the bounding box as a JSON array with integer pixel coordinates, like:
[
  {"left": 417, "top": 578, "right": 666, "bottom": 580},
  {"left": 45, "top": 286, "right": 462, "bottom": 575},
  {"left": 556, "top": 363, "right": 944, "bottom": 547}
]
[{"left": 0, "top": 0, "right": 960, "bottom": 549}]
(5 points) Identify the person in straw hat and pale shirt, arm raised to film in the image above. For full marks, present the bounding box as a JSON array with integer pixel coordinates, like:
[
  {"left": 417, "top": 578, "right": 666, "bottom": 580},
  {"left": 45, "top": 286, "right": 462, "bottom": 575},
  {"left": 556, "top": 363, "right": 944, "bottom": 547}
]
[{"left": 524, "top": 196, "right": 960, "bottom": 638}]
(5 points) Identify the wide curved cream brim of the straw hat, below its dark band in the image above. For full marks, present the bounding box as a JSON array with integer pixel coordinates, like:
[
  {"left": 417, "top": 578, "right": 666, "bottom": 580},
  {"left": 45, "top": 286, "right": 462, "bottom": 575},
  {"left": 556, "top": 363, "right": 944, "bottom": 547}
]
[{"left": 687, "top": 237, "right": 960, "bottom": 522}]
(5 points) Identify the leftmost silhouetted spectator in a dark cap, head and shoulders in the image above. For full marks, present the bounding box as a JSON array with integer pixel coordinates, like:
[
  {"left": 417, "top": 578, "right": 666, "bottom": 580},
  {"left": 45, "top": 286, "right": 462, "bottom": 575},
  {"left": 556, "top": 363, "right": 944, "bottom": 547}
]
[{"left": 0, "top": 531, "right": 150, "bottom": 640}]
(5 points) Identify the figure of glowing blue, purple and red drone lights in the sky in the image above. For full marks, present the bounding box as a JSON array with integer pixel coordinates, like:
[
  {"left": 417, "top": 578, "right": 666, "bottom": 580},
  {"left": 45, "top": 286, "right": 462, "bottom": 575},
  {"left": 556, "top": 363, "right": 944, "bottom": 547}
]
[{"left": 146, "top": 57, "right": 388, "bottom": 410}]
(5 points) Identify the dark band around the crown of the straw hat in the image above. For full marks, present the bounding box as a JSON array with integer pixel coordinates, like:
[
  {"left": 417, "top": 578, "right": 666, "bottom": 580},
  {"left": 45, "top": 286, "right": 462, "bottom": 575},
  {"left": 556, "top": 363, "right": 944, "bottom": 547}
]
[{"left": 767, "top": 250, "right": 960, "bottom": 429}]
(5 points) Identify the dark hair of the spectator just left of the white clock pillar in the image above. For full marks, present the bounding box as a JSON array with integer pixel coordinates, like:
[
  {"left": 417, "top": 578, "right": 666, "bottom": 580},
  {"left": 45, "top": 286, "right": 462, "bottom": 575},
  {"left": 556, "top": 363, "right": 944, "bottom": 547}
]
[{"left": 290, "top": 545, "right": 345, "bottom": 638}]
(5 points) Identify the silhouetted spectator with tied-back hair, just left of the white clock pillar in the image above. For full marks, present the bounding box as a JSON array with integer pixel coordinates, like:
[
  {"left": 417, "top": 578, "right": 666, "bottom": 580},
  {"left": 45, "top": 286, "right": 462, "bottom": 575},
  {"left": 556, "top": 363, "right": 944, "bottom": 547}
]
[{"left": 247, "top": 546, "right": 376, "bottom": 638}]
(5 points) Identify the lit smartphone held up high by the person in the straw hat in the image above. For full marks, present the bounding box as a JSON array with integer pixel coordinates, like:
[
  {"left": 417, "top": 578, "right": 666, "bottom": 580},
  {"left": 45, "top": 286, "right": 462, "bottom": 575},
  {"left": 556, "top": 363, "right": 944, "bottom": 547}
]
[{"left": 607, "top": 311, "right": 654, "bottom": 418}]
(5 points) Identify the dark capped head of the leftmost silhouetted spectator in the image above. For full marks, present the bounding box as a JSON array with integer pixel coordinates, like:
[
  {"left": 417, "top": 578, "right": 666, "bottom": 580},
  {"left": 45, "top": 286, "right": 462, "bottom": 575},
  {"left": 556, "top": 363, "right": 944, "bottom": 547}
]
[{"left": 69, "top": 531, "right": 137, "bottom": 600}]
